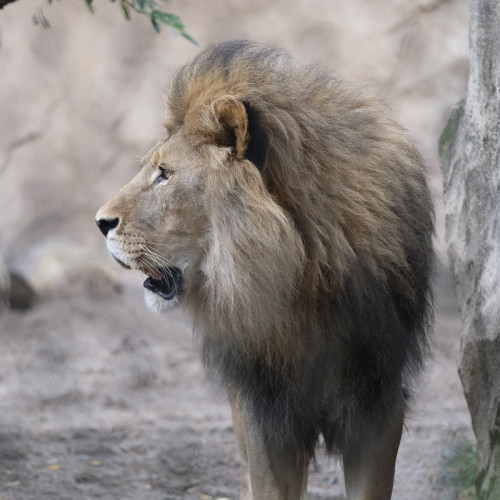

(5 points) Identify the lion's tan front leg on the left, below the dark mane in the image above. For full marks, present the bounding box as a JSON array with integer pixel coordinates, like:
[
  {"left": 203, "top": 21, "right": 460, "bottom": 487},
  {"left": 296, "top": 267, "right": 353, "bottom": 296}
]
[{"left": 229, "top": 393, "right": 309, "bottom": 500}]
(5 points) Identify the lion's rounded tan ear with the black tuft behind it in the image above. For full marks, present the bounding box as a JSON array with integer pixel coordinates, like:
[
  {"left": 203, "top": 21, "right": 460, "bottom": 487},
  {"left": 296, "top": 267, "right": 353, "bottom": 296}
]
[{"left": 214, "top": 100, "right": 269, "bottom": 171}]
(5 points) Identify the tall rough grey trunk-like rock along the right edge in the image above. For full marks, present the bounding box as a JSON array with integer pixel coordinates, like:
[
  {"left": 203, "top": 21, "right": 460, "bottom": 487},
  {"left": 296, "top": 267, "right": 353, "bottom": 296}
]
[{"left": 440, "top": 0, "right": 500, "bottom": 500}]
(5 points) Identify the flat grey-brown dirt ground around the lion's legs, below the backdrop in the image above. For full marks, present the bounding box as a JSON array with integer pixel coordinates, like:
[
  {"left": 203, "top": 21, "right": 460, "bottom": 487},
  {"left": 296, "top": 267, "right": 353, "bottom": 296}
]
[{"left": 0, "top": 262, "right": 470, "bottom": 500}]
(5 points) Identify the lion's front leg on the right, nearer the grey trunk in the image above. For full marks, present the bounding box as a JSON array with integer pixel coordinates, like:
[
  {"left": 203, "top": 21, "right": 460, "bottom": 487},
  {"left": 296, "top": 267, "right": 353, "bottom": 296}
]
[{"left": 343, "top": 403, "right": 404, "bottom": 500}]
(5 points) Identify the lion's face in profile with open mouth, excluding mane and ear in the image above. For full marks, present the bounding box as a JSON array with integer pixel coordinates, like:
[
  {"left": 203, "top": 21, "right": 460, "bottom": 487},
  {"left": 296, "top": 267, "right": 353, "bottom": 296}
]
[{"left": 97, "top": 133, "right": 209, "bottom": 310}]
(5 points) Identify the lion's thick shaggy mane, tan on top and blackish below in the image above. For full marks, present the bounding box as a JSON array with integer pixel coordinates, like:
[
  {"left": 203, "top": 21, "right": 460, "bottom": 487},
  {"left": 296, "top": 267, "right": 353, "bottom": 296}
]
[{"left": 166, "top": 42, "right": 433, "bottom": 458}]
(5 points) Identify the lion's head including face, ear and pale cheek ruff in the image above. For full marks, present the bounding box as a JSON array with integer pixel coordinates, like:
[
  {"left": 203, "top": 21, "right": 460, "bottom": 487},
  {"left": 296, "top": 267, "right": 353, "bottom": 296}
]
[{"left": 96, "top": 48, "right": 304, "bottom": 342}]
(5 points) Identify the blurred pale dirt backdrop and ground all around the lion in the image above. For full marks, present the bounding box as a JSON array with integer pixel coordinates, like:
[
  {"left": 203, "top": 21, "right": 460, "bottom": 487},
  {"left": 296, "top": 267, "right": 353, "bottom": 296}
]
[{"left": 0, "top": 0, "right": 472, "bottom": 500}]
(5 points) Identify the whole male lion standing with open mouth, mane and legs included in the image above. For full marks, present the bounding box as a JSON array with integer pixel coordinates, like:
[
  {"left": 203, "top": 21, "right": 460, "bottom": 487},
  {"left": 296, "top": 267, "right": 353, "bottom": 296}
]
[{"left": 97, "top": 41, "right": 433, "bottom": 500}]
